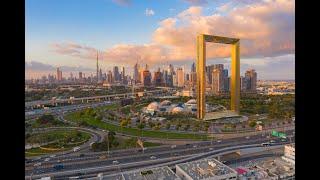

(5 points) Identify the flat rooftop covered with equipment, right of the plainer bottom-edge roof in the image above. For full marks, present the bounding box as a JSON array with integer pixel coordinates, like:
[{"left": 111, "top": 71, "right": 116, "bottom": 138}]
[{"left": 176, "top": 158, "right": 237, "bottom": 179}]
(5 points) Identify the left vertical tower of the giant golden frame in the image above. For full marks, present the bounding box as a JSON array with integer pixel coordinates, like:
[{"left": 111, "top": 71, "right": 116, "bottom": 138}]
[{"left": 196, "top": 35, "right": 206, "bottom": 119}]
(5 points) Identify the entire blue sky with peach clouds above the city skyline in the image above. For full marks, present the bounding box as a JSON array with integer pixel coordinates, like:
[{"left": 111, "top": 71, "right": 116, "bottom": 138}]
[{"left": 25, "top": 0, "right": 295, "bottom": 80}]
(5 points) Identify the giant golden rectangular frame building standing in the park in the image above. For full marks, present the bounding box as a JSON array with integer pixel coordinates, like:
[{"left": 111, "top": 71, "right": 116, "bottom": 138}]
[{"left": 196, "top": 34, "right": 240, "bottom": 120}]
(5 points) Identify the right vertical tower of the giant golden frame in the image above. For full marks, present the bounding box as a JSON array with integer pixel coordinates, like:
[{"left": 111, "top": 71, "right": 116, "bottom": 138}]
[{"left": 230, "top": 41, "right": 240, "bottom": 113}]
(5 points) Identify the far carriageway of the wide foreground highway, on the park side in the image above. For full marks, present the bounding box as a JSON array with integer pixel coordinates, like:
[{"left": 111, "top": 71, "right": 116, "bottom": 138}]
[{"left": 25, "top": 132, "right": 294, "bottom": 177}]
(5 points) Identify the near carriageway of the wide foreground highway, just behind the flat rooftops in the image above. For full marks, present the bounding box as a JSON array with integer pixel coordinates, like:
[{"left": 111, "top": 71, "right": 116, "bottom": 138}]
[{"left": 26, "top": 142, "right": 292, "bottom": 179}]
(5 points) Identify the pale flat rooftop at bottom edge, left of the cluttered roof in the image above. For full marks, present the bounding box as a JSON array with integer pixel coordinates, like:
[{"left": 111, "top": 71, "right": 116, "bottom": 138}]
[{"left": 103, "top": 166, "right": 181, "bottom": 180}]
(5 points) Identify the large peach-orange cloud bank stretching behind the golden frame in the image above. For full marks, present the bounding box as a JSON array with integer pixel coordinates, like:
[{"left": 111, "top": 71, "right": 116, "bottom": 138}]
[{"left": 52, "top": 0, "right": 295, "bottom": 67}]
